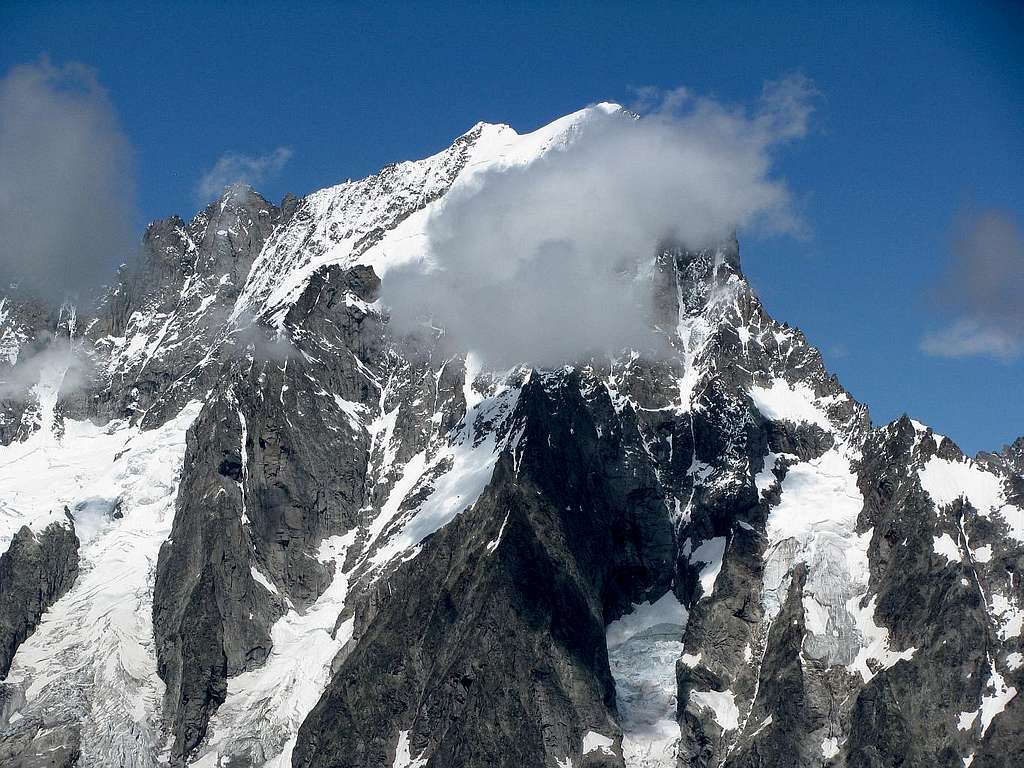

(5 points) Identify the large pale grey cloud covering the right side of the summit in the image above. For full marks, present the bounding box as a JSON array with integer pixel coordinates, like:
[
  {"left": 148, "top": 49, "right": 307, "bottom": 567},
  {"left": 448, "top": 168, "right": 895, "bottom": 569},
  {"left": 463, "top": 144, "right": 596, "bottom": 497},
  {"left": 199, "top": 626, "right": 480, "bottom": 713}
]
[{"left": 382, "top": 77, "right": 814, "bottom": 367}]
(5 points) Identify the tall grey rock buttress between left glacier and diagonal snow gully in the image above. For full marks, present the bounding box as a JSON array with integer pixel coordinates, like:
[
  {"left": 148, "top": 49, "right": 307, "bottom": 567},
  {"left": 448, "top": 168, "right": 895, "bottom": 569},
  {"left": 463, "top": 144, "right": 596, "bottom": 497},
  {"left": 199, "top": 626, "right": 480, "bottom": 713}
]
[{"left": 154, "top": 262, "right": 380, "bottom": 762}]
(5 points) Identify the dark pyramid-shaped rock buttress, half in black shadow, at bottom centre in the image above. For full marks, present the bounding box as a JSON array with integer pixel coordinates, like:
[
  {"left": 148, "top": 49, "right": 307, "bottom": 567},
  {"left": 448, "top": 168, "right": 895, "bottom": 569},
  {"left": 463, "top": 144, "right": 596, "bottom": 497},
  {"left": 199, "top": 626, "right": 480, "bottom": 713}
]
[{"left": 295, "top": 372, "right": 674, "bottom": 766}]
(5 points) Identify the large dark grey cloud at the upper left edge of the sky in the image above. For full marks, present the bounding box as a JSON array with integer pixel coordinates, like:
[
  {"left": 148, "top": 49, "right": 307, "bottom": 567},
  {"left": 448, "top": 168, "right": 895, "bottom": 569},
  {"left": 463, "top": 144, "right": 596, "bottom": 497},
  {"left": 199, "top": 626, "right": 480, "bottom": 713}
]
[{"left": 0, "top": 58, "right": 135, "bottom": 301}]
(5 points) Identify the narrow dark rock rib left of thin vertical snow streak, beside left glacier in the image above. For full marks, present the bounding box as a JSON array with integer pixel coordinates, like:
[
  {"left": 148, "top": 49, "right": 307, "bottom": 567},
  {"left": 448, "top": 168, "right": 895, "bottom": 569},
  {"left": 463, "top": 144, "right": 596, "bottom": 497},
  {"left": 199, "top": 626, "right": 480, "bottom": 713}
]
[{"left": 154, "top": 399, "right": 283, "bottom": 759}]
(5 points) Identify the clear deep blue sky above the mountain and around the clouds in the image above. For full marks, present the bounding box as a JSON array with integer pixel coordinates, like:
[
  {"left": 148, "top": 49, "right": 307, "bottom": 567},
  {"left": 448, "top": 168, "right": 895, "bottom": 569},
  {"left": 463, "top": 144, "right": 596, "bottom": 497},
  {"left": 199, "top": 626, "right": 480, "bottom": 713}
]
[{"left": 0, "top": 0, "right": 1024, "bottom": 452}]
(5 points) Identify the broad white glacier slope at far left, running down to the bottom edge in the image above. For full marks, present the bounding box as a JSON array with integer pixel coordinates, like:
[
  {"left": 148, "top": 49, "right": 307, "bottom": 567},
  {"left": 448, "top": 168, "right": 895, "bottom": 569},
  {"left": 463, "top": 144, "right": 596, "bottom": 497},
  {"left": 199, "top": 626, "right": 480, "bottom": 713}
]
[{"left": 0, "top": 402, "right": 201, "bottom": 768}]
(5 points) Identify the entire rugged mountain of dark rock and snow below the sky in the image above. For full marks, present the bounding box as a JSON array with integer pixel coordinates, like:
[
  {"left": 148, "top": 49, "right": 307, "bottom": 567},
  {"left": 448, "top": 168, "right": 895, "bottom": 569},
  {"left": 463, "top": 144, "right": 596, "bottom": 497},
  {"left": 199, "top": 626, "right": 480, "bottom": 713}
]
[{"left": 0, "top": 105, "right": 1024, "bottom": 768}]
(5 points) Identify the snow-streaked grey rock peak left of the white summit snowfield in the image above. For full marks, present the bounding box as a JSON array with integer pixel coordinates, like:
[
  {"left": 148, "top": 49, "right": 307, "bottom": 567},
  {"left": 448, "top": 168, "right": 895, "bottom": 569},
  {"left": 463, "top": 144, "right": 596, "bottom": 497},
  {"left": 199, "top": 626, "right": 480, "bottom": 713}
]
[{"left": 80, "top": 186, "right": 294, "bottom": 427}]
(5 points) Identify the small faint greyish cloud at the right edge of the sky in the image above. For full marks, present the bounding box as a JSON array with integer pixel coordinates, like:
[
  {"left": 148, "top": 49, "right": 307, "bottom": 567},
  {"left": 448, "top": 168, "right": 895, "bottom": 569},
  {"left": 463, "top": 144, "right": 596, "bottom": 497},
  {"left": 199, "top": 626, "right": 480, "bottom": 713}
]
[{"left": 921, "top": 210, "right": 1024, "bottom": 362}]
